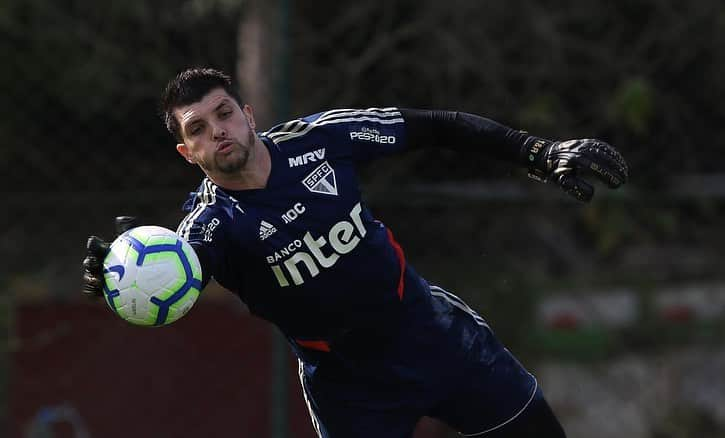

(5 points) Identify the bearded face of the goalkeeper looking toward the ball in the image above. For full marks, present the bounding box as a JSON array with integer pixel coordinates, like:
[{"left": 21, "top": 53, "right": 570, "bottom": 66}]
[{"left": 174, "top": 88, "right": 256, "bottom": 179}]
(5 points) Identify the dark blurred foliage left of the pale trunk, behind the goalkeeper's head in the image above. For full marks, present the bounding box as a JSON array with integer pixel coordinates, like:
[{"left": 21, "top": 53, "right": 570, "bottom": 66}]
[{"left": 0, "top": 0, "right": 240, "bottom": 191}]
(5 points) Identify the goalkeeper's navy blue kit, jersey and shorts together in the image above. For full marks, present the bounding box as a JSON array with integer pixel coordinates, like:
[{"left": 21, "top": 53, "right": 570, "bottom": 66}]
[{"left": 178, "top": 108, "right": 540, "bottom": 438}]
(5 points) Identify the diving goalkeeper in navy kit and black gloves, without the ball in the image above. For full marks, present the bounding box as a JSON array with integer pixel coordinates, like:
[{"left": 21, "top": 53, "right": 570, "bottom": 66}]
[{"left": 84, "top": 68, "right": 628, "bottom": 438}]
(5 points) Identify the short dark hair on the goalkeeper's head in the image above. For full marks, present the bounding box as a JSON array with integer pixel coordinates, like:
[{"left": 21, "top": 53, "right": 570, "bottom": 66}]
[{"left": 160, "top": 67, "right": 242, "bottom": 141}]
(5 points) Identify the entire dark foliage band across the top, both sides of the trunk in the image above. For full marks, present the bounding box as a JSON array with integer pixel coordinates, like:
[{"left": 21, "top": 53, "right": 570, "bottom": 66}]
[{"left": 0, "top": 0, "right": 725, "bottom": 190}]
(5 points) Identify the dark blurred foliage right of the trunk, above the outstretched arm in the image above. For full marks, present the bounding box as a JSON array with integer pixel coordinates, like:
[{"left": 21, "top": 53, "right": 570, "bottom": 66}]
[{"left": 292, "top": 0, "right": 725, "bottom": 189}]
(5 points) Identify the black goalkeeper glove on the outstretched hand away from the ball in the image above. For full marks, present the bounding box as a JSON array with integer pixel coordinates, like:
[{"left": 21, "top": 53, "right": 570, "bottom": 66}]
[{"left": 522, "top": 137, "right": 629, "bottom": 202}]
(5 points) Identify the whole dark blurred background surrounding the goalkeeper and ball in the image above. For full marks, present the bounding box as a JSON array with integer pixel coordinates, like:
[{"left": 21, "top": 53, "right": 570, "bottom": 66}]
[{"left": 0, "top": 0, "right": 725, "bottom": 438}]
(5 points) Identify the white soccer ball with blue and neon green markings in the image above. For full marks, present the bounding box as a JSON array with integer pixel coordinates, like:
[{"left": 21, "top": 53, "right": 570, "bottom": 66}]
[{"left": 103, "top": 226, "right": 201, "bottom": 326}]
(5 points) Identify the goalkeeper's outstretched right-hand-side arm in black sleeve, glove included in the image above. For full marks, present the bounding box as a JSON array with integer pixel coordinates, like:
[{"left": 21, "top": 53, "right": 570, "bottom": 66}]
[{"left": 400, "top": 109, "right": 629, "bottom": 202}]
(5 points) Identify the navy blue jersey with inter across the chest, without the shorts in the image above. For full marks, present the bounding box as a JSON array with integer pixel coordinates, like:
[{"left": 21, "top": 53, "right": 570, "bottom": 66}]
[{"left": 178, "top": 108, "right": 418, "bottom": 340}]
